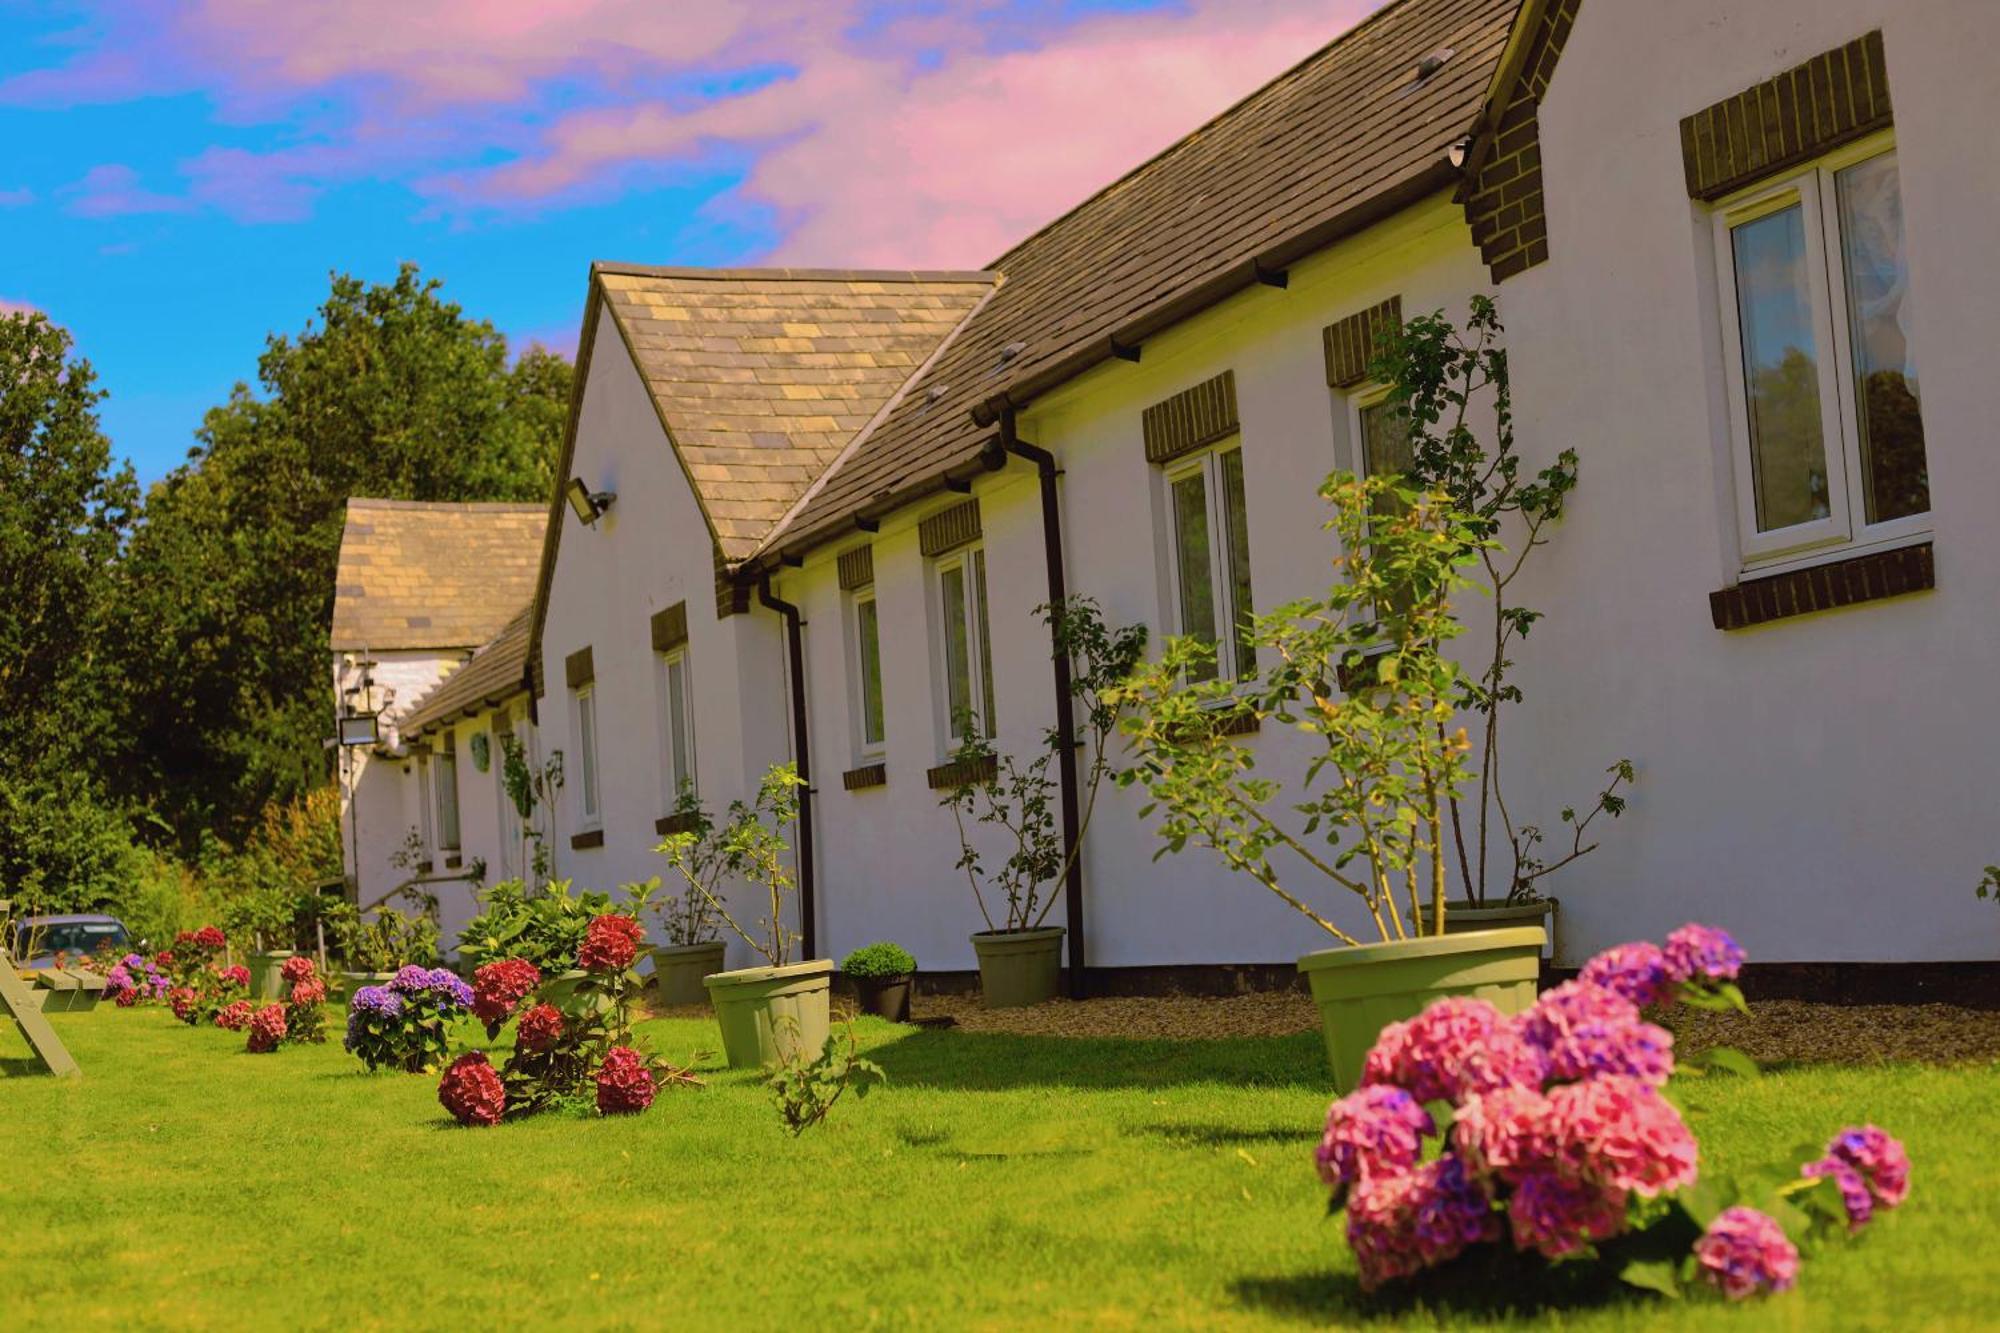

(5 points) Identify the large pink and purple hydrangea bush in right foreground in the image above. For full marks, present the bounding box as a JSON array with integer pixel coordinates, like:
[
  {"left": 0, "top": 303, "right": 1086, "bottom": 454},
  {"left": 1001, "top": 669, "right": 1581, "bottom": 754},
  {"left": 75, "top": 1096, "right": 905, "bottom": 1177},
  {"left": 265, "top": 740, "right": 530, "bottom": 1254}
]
[{"left": 1316, "top": 925, "right": 1910, "bottom": 1299}]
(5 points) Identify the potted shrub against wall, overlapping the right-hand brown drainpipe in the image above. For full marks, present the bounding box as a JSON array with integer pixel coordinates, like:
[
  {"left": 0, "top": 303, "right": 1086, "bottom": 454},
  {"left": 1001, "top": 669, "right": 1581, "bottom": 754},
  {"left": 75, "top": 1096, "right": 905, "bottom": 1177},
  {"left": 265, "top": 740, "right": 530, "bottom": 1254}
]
[{"left": 940, "top": 596, "right": 1146, "bottom": 1009}]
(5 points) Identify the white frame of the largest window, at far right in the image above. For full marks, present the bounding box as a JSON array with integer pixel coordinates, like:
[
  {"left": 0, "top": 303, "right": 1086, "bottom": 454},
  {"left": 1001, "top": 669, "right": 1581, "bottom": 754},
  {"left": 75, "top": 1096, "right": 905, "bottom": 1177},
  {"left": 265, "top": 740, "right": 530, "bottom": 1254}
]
[{"left": 1712, "top": 132, "right": 1932, "bottom": 574}]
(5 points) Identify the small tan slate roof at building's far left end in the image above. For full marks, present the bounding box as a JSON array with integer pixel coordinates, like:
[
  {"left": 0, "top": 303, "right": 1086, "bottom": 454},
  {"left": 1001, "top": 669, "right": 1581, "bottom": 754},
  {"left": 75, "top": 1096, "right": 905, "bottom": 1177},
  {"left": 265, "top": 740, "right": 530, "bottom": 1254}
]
[{"left": 332, "top": 498, "right": 548, "bottom": 652}]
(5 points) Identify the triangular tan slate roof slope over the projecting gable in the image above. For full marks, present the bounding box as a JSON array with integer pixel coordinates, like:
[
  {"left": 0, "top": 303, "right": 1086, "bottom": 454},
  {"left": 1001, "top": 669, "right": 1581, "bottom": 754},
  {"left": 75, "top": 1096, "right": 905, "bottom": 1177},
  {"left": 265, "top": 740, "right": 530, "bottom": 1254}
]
[{"left": 594, "top": 264, "right": 994, "bottom": 560}]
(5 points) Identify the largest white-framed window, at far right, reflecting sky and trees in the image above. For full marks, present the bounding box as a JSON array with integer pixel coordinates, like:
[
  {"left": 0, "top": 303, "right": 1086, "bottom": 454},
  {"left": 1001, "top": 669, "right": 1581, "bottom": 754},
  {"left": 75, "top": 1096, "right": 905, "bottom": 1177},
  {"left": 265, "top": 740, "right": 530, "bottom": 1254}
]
[{"left": 1716, "top": 138, "right": 1930, "bottom": 564}]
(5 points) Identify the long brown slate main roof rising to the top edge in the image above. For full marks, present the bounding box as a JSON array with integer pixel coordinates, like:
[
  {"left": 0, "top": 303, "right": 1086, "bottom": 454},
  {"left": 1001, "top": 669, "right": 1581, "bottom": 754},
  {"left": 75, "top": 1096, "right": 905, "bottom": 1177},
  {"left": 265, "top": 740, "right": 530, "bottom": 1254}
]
[{"left": 764, "top": 0, "right": 1518, "bottom": 550}]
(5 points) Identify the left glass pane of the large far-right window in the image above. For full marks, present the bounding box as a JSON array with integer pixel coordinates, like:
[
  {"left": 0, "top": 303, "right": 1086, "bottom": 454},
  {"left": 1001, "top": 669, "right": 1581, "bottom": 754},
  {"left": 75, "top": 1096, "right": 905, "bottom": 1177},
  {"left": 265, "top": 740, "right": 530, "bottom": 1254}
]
[{"left": 1730, "top": 204, "right": 1828, "bottom": 532}]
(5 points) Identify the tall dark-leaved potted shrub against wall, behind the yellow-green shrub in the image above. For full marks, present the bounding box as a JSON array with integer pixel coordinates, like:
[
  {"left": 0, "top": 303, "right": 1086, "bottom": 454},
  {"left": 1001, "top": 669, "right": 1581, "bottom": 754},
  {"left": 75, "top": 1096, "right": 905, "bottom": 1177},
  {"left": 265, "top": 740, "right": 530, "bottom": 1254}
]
[{"left": 1372, "top": 296, "right": 1636, "bottom": 935}]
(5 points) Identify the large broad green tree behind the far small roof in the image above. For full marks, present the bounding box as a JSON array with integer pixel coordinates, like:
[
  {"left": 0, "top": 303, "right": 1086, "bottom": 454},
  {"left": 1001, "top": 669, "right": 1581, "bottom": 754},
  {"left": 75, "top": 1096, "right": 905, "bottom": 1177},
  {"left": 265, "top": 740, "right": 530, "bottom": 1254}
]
[{"left": 116, "top": 264, "right": 570, "bottom": 855}]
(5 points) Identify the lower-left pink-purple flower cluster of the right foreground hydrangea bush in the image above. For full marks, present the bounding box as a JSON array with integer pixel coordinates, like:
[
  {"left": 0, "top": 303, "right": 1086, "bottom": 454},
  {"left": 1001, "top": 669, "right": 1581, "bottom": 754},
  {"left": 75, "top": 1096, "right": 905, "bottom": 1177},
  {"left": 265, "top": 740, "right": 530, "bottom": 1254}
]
[{"left": 1348, "top": 1157, "right": 1500, "bottom": 1291}]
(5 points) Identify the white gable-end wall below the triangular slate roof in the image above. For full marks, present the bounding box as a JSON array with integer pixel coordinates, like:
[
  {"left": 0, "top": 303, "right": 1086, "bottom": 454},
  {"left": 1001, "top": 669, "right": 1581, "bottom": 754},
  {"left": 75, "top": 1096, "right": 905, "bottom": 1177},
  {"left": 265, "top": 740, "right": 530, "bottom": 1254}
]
[{"left": 538, "top": 314, "right": 790, "bottom": 965}]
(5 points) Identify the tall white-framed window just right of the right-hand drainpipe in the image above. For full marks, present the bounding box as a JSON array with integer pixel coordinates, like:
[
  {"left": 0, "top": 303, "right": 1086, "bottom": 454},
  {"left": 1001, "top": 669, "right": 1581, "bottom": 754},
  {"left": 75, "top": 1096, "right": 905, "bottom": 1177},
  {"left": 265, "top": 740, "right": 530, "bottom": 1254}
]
[{"left": 1166, "top": 442, "right": 1256, "bottom": 679}]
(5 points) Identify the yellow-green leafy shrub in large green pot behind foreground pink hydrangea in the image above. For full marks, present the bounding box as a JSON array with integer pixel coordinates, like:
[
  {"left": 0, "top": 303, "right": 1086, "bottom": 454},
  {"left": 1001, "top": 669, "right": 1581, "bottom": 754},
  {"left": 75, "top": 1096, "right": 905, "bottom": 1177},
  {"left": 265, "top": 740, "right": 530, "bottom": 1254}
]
[{"left": 1118, "top": 472, "right": 1546, "bottom": 1091}]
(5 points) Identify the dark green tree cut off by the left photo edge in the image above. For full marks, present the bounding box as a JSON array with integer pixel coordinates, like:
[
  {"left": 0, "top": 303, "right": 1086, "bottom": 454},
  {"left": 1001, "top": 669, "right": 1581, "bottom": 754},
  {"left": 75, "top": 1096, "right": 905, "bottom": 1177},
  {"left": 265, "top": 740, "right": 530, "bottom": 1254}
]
[{"left": 0, "top": 312, "right": 138, "bottom": 907}]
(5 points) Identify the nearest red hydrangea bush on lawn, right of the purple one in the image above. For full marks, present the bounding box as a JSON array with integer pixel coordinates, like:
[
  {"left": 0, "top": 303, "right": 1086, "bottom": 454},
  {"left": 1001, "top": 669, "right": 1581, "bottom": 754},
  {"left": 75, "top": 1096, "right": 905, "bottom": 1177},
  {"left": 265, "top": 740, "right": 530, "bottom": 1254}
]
[{"left": 438, "top": 913, "right": 694, "bottom": 1127}]
